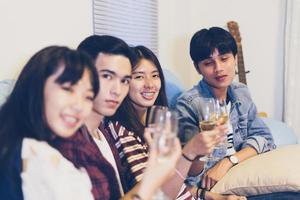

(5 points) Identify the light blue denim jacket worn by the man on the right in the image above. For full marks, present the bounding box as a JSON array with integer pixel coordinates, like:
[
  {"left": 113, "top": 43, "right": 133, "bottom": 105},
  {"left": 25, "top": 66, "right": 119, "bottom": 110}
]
[{"left": 176, "top": 80, "right": 276, "bottom": 154}]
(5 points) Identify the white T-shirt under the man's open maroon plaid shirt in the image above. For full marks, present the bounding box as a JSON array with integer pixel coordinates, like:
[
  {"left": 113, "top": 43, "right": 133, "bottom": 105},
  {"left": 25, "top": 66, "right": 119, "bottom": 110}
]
[{"left": 93, "top": 129, "right": 124, "bottom": 196}]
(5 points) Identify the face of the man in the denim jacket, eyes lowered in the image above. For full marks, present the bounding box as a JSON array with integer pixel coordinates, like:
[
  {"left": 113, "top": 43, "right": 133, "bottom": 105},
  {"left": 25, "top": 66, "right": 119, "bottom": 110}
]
[{"left": 197, "top": 49, "right": 237, "bottom": 89}]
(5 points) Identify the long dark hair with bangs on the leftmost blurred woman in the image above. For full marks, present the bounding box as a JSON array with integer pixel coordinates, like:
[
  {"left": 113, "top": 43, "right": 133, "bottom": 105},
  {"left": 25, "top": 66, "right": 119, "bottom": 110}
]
[{"left": 0, "top": 46, "right": 99, "bottom": 173}]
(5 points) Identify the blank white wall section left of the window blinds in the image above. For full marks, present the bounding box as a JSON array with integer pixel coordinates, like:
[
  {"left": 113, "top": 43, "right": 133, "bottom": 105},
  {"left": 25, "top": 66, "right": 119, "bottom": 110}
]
[{"left": 0, "top": 0, "right": 93, "bottom": 80}]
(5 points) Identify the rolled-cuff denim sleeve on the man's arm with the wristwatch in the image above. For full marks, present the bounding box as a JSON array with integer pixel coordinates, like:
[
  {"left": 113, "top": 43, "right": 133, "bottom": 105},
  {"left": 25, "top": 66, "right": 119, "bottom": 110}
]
[{"left": 242, "top": 102, "right": 276, "bottom": 154}]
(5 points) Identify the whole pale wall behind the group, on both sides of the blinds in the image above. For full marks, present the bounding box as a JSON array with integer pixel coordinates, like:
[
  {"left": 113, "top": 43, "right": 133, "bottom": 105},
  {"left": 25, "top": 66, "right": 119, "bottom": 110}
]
[{"left": 0, "top": 0, "right": 284, "bottom": 119}]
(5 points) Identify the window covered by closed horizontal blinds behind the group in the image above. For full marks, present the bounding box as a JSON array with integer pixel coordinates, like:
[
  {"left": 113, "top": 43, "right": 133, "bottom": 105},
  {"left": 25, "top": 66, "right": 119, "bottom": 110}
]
[{"left": 93, "top": 0, "right": 158, "bottom": 53}]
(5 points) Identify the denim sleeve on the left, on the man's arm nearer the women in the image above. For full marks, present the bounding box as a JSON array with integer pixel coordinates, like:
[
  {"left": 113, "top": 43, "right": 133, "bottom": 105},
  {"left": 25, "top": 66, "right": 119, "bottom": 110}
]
[{"left": 176, "top": 98, "right": 199, "bottom": 144}]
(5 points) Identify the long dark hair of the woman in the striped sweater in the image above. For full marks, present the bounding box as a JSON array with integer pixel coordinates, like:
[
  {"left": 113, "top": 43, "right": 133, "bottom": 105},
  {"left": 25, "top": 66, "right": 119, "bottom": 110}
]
[{"left": 111, "top": 46, "right": 168, "bottom": 140}]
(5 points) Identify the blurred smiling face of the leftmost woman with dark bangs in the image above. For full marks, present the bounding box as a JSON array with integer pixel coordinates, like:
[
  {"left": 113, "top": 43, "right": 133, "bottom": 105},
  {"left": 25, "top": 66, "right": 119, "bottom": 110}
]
[{"left": 44, "top": 66, "right": 94, "bottom": 138}]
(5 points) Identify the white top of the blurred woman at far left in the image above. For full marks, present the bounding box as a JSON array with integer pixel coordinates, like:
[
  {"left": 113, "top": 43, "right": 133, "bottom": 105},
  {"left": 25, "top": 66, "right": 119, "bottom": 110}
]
[{"left": 21, "top": 138, "right": 94, "bottom": 200}]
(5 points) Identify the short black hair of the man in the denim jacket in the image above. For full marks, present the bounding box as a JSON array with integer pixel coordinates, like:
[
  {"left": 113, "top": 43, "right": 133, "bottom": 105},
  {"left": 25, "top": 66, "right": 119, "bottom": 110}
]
[{"left": 190, "top": 27, "right": 237, "bottom": 64}]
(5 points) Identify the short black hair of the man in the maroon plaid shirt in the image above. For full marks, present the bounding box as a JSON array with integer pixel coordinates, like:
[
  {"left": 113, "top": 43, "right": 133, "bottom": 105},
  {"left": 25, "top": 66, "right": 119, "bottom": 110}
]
[{"left": 77, "top": 35, "right": 135, "bottom": 66}]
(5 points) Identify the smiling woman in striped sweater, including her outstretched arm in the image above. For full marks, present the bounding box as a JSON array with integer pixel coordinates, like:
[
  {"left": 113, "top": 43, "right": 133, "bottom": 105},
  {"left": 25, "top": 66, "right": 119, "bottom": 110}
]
[{"left": 107, "top": 46, "right": 234, "bottom": 199}]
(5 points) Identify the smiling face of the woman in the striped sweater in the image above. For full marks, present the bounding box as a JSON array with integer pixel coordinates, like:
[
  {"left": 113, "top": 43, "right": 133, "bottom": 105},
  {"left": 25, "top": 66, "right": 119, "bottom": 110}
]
[{"left": 129, "top": 59, "right": 161, "bottom": 111}]
